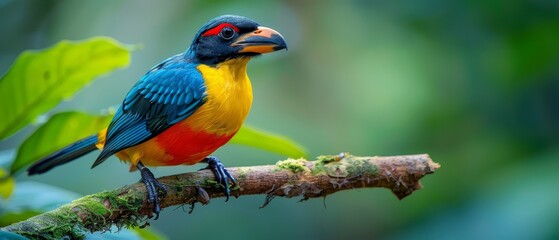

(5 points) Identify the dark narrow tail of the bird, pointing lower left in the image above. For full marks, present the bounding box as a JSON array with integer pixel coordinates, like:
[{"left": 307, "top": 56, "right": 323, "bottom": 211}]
[{"left": 27, "top": 135, "right": 97, "bottom": 175}]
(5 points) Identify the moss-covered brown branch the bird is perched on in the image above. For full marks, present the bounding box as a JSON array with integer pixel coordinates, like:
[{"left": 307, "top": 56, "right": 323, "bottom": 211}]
[{"left": 0, "top": 154, "right": 440, "bottom": 239}]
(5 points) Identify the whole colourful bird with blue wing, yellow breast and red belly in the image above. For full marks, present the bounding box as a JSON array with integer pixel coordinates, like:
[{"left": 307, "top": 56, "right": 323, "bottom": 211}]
[{"left": 27, "top": 15, "right": 287, "bottom": 219}]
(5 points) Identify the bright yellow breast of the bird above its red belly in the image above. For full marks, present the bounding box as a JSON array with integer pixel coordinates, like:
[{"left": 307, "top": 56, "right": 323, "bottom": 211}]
[{"left": 183, "top": 58, "right": 252, "bottom": 135}]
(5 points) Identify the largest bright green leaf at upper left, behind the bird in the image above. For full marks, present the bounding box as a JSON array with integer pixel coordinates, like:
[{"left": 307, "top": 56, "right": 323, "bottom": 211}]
[{"left": 0, "top": 37, "right": 131, "bottom": 140}]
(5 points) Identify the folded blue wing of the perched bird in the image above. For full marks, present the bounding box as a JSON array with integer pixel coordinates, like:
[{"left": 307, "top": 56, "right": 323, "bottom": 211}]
[{"left": 92, "top": 55, "right": 206, "bottom": 168}]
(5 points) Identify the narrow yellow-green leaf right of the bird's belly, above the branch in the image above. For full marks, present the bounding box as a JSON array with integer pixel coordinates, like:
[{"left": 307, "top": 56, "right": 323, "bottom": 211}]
[{"left": 230, "top": 125, "right": 307, "bottom": 158}]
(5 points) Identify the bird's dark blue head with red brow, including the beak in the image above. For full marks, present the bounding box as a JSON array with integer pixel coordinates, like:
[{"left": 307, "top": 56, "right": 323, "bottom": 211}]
[{"left": 188, "top": 15, "right": 287, "bottom": 65}]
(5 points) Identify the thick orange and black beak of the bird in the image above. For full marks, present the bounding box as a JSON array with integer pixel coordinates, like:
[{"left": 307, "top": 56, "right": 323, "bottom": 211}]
[{"left": 231, "top": 27, "right": 287, "bottom": 53}]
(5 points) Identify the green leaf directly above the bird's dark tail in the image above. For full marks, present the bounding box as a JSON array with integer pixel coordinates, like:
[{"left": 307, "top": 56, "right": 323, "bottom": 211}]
[{"left": 10, "top": 112, "right": 112, "bottom": 174}]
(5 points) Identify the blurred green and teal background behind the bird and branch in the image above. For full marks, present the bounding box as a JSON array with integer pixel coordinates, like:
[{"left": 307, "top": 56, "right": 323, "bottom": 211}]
[{"left": 0, "top": 0, "right": 559, "bottom": 239}]
